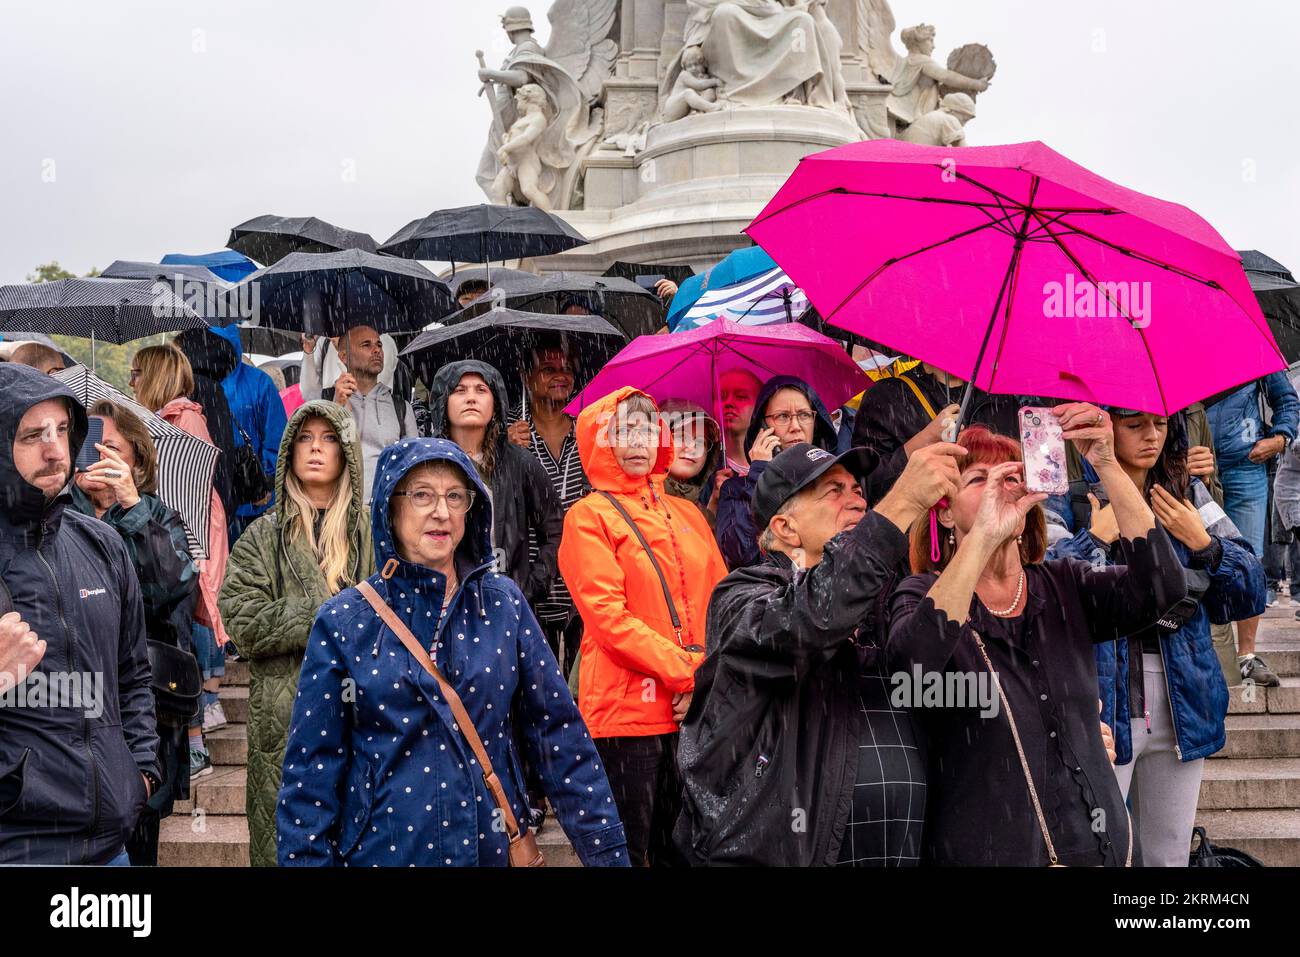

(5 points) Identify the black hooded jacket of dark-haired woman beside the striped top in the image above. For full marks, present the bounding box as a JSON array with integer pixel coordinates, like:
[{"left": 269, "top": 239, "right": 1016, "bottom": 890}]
[{"left": 429, "top": 359, "right": 564, "bottom": 609}]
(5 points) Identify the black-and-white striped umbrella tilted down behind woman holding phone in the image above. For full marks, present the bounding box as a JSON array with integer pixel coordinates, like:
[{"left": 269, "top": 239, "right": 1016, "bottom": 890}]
[{"left": 55, "top": 365, "right": 221, "bottom": 559}]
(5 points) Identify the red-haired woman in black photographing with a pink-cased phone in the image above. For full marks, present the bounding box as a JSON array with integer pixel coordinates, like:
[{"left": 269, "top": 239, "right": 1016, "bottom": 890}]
[{"left": 885, "top": 403, "right": 1187, "bottom": 866}]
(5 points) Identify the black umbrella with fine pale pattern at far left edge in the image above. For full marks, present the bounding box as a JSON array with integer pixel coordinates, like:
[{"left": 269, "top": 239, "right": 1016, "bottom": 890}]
[{"left": 0, "top": 278, "right": 208, "bottom": 364}]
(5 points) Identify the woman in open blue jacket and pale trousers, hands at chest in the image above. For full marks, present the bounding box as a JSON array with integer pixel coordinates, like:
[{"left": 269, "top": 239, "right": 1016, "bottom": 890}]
[{"left": 1048, "top": 410, "right": 1266, "bottom": 867}]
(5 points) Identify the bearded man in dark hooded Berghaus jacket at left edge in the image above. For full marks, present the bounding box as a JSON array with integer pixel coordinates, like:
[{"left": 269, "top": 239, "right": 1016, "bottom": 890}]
[{"left": 0, "top": 363, "right": 159, "bottom": 865}]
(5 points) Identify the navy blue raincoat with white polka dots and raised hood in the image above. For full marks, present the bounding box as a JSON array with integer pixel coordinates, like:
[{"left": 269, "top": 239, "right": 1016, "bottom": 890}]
[{"left": 276, "top": 438, "right": 628, "bottom": 867}]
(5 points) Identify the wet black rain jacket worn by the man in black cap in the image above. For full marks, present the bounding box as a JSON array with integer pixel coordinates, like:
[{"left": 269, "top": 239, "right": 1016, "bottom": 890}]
[{"left": 675, "top": 512, "right": 910, "bottom": 866}]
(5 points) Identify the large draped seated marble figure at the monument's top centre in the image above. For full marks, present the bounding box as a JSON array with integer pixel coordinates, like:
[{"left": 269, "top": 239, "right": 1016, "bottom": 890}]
[{"left": 660, "top": 0, "right": 848, "bottom": 109}]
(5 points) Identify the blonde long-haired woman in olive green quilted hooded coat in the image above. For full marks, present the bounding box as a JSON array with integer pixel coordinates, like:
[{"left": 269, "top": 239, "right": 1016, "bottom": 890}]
[{"left": 221, "top": 399, "right": 374, "bottom": 867}]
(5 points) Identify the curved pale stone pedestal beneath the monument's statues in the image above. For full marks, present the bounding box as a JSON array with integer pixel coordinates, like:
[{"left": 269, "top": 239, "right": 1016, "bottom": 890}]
[{"left": 534, "top": 100, "right": 889, "bottom": 273}]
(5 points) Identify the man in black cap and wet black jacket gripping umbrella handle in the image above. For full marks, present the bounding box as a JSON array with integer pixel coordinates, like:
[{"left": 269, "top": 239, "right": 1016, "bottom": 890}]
[{"left": 675, "top": 443, "right": 962, "bottom": 866}]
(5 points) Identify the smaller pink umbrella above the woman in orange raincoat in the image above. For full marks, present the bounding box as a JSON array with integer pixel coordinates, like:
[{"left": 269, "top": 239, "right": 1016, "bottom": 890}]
[{"left": 564, "top": 319, "right": 871, "bottom": 421}]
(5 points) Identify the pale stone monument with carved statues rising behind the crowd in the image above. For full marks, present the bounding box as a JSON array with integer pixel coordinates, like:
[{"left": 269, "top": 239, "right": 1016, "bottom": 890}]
[{"left": 478, "top": 0, "right": 993, "bottom": 272}]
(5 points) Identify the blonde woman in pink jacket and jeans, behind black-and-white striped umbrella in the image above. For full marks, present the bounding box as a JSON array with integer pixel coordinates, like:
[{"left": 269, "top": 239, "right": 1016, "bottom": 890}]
[{"left": 131, "top": 346, "right": 230, "bottom": 778}]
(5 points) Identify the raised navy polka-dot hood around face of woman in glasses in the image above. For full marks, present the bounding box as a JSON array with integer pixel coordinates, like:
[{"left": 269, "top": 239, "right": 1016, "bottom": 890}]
[{"left": 371, "top": 438, "right": 493, "bottom": 577}]
